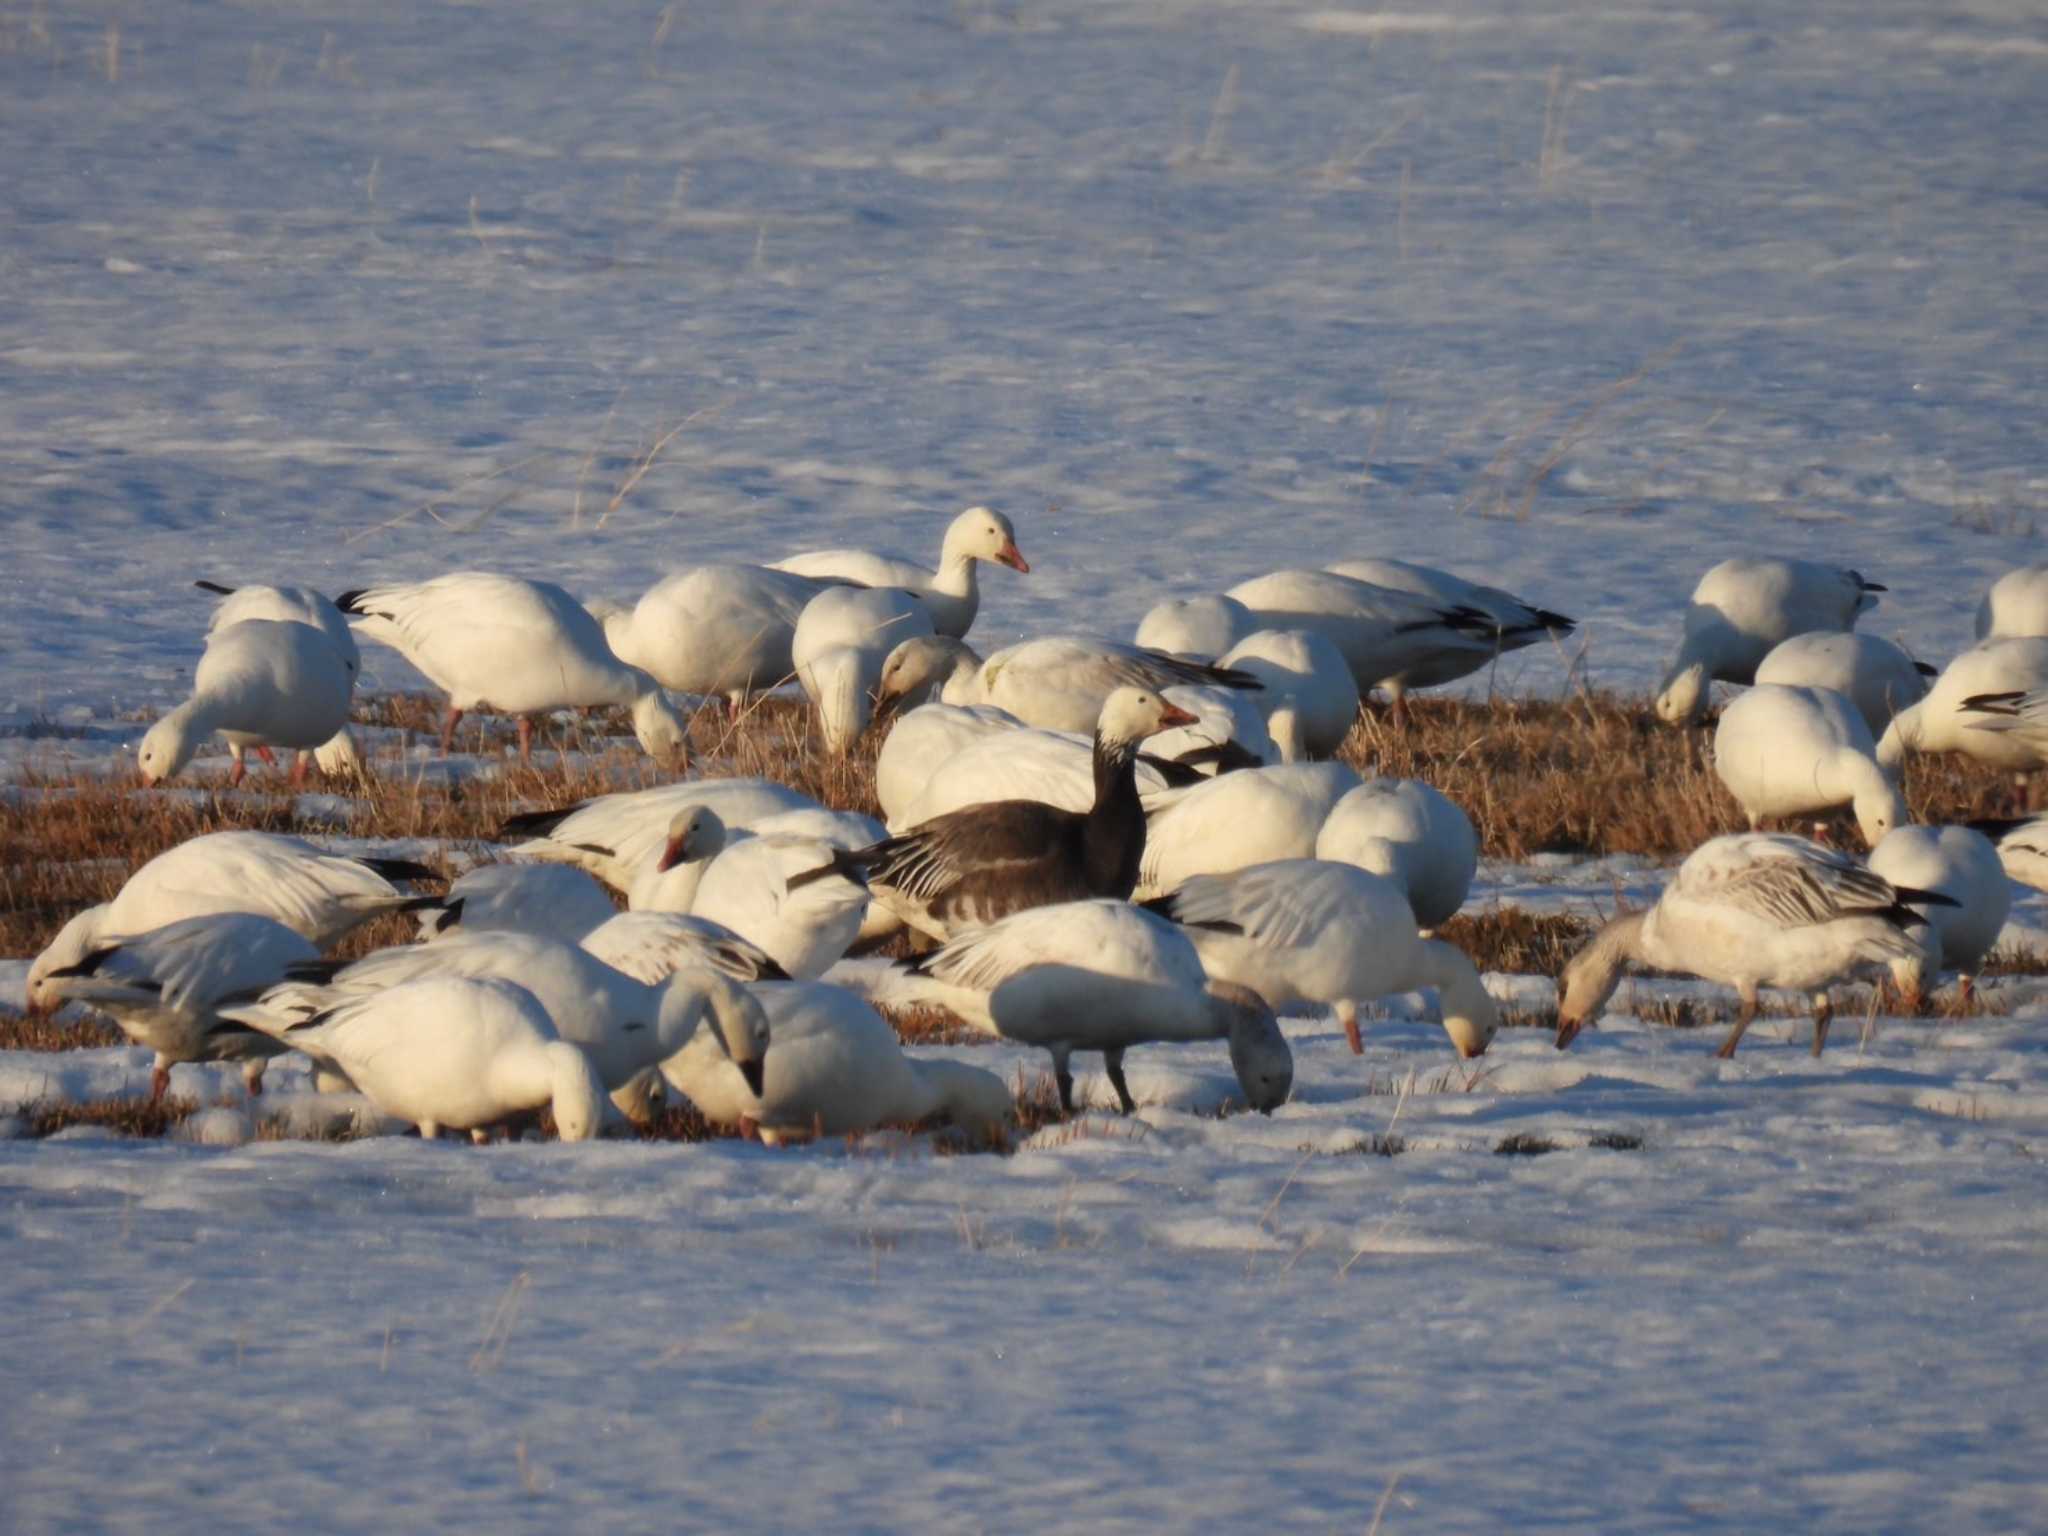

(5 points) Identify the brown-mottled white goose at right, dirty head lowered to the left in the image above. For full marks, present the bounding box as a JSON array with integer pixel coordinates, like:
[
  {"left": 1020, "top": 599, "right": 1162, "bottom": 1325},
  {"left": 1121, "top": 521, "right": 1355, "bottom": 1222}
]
[{"left": 1556, "top": 831, "right": 1950, "bottom": 1059}]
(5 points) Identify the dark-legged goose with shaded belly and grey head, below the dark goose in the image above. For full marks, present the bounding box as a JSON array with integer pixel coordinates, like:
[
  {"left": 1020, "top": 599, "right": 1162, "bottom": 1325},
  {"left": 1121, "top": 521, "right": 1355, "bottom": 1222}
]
[{"left": 911, "top": 899, "right": 1294, "bottom": 1114}]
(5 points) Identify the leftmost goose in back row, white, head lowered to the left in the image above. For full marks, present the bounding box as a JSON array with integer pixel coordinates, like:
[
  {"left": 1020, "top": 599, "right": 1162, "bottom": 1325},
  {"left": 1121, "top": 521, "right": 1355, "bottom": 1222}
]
[{"left": 135, "top": 618, "right": 356, "bottom": 784}]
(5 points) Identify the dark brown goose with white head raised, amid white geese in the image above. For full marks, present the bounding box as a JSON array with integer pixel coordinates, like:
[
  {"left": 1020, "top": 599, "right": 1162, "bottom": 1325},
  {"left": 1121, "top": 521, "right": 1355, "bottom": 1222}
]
[{"left": 850, "top": 688, "right": 1196, "bottom": 940}]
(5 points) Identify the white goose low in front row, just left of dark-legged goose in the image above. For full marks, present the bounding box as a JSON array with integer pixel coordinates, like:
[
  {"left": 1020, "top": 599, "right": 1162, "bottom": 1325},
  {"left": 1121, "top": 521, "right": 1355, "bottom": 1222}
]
[{"left": 668, "top": 981, "right": 1010, "bottom": 1147}]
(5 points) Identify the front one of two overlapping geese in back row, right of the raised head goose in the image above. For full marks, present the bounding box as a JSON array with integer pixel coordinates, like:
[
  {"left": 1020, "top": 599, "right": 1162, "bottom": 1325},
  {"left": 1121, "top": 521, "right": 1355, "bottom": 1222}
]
[{"left": 1231, "top": 569, "right": 1499, "bottom": 725}]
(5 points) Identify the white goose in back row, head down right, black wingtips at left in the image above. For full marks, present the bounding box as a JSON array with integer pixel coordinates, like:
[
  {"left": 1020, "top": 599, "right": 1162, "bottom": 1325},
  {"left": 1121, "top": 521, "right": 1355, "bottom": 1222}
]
[{"left": 336, "top": 571, "right": 688, "bottom": 764}]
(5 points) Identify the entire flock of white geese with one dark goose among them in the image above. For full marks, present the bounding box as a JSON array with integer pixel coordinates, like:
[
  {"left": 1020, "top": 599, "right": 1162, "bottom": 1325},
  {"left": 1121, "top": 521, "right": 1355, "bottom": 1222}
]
[{"left": 29, "top": 506, "right": 2048, "bottom": 1141}]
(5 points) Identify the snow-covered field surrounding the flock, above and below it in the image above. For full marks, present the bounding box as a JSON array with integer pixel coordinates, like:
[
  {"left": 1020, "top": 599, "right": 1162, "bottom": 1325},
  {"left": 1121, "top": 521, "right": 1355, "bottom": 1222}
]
[{"left": 0, "top": 0, "right": 2048, "bottom": 1532}]
